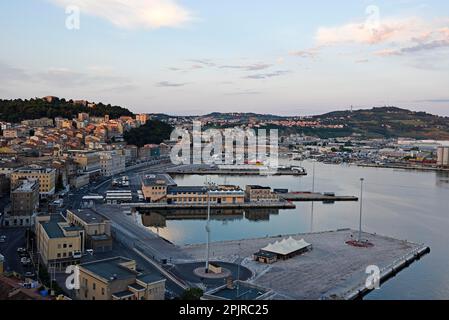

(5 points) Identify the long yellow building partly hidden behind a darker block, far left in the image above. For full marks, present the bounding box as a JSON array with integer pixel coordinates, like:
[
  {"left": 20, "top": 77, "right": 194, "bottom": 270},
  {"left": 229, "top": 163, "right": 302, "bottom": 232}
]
[{"left": 11, "top": 165, "right": 56, "bottom": 198}]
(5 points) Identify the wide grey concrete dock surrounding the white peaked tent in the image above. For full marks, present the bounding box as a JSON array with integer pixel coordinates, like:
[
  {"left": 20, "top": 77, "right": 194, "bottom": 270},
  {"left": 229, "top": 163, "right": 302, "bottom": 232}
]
[{"left": 182, "top": 229, "right": 430, "bottom": 300}]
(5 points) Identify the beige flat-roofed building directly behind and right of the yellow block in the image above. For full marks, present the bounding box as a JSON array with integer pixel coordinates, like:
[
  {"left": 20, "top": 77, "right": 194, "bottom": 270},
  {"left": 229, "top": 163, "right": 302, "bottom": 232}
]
[{"left": 67, "top": 209, "right": 112, "bottom": 252}]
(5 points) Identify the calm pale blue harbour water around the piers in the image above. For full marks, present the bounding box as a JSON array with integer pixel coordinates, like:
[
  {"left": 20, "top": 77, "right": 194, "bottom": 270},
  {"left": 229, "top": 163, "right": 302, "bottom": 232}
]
[{"left": 144, "top": 162, "right": 449, "bottom": 299}]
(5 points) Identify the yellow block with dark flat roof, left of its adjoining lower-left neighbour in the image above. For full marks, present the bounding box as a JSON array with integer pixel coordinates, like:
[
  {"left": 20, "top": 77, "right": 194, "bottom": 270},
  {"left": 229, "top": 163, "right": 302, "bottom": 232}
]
[{"left": 35, "top": 214, "right": 84, "bottom": 270}]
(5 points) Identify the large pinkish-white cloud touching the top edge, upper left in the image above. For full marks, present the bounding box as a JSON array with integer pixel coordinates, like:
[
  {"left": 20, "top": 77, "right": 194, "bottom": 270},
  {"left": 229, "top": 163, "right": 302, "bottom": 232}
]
[{"left": 50, "top": 0, "right": 192, "bottom": 29}]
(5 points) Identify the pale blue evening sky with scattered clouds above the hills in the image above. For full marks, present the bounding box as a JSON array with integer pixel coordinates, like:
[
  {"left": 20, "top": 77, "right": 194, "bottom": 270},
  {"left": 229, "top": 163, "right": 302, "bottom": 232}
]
[{"left": 0, "top": 0, "right": 449, "bottom": 115}]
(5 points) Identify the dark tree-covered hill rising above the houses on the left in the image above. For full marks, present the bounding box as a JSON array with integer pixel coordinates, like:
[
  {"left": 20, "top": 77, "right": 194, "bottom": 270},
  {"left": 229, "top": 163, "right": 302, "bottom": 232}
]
[{"left": 0, "top": 97, "right": 133, "bottom": 123}]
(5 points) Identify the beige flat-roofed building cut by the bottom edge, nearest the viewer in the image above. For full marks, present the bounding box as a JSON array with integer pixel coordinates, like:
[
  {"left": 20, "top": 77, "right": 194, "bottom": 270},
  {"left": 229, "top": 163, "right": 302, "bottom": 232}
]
[{"left": 77, "top": 257, "right": 166, "bottom": 300}]
